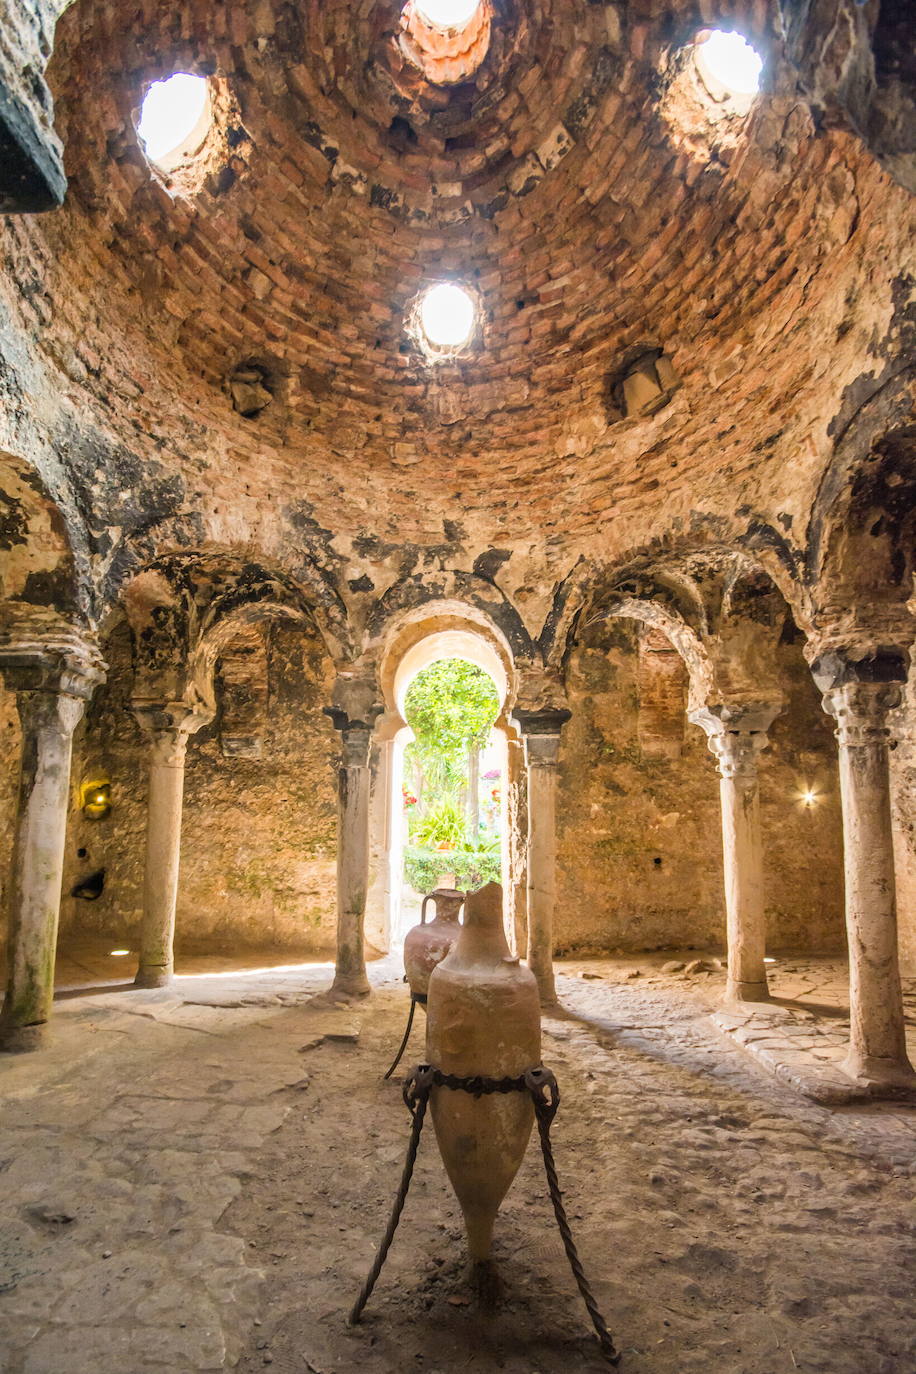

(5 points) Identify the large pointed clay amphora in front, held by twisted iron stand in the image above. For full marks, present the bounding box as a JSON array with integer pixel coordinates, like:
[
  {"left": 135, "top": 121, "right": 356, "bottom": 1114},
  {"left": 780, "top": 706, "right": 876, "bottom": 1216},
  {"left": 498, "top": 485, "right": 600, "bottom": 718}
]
[{"left": 426, "top": 882, "right": 541, "bottom": 1265}]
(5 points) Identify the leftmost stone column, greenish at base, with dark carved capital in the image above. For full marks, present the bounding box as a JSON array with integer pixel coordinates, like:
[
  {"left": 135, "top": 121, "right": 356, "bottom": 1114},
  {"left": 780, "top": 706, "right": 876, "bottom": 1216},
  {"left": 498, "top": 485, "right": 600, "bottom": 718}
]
[{"left": 0, "top": 638, "right": 104, "bottom": 1051}]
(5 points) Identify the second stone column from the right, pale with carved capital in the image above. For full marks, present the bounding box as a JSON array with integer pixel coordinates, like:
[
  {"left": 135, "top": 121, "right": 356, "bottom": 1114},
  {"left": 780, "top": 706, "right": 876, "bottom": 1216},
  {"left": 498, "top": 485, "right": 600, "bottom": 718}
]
[{"left": 689, "top": 702, "right": 780, "bottom": 1002}]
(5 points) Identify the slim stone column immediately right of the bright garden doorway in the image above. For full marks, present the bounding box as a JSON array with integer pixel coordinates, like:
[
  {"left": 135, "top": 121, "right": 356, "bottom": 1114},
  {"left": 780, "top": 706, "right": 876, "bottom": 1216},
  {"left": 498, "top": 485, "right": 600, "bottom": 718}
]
[{"left": 512, "top": 708, "right": 570, "bottom": 1007}]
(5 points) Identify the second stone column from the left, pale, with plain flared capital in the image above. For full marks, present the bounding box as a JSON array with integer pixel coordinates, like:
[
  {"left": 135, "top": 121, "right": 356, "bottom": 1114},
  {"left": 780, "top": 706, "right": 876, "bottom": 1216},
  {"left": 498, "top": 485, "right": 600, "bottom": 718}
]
[{"left": 133, "top": 701, "right": 213, "bottom": 988}]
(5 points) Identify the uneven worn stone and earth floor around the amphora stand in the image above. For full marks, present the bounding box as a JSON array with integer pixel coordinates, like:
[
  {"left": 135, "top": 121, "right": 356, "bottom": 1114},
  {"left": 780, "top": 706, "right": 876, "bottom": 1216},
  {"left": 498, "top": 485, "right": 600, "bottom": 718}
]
[{"left": 0, "top": 954, "right": 916, "bottom": 1374}]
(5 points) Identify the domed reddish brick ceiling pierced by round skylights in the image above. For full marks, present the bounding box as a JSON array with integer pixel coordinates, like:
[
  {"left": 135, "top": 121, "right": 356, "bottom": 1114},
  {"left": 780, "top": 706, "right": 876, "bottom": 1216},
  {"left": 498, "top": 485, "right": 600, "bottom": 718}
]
[{"left": 7, "top": 0, "right": 912, "bottom": 607}]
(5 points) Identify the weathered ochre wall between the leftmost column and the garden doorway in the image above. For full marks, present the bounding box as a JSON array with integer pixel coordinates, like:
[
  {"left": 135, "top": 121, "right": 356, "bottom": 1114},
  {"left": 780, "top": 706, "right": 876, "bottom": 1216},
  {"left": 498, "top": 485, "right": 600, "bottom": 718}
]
[{"left": 62, "top": 627, "right": 343, "bottom": 952}]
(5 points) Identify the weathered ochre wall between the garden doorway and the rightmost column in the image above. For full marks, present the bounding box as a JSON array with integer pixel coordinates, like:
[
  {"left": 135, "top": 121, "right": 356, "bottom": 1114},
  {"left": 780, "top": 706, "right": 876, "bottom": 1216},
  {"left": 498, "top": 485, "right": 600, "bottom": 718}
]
[{"left": 556, "top": 621, "right": 843, "bottom": 951}]
